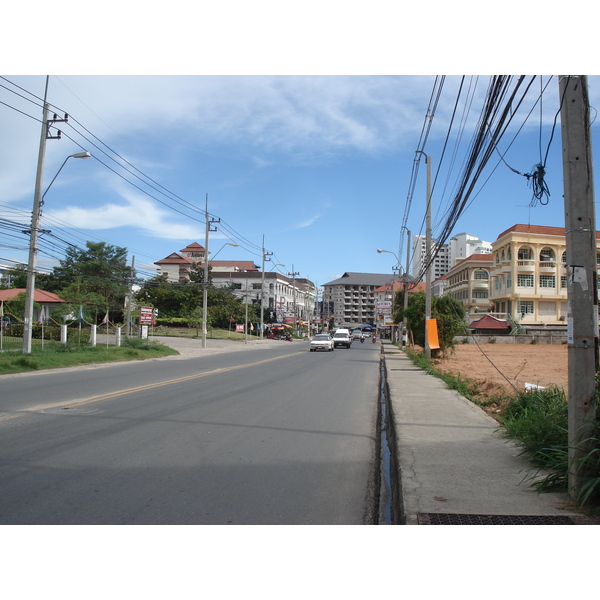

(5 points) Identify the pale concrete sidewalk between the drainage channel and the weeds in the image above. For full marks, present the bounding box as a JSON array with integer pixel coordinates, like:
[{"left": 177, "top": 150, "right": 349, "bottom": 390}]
[{"left": 382, "top": 340, "right": 590, "bottom": 525}]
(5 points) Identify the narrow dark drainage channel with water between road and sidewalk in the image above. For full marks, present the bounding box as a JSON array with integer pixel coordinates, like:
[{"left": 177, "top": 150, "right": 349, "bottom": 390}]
[{"left": 377, "top": 355, "right": 402, "bottom": 525}]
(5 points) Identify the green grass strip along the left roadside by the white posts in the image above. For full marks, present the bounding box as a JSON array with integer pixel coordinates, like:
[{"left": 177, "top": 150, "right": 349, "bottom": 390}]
[{"left": 0, "top": 339, "right": 179, "bottom": 374}]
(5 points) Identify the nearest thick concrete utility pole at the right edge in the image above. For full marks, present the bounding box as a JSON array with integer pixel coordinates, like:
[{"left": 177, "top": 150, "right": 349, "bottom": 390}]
[{"left": 559, "top": 75, "right": 598, "bottom": 499}]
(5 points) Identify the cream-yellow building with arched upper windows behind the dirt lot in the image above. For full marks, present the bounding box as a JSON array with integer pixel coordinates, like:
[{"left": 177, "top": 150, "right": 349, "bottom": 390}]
[{"left": 490, "top": 225, "right": 598, "bottom": 326}]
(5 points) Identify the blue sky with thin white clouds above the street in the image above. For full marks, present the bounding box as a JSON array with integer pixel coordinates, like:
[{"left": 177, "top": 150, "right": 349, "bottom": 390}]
[{"left": 0, "top": 7, "right": 600, "bottom": 296}]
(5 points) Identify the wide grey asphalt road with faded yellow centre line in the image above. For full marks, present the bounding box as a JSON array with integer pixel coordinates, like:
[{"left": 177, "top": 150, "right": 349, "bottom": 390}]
[{"left": 0, "top": 342, "right": 379, "bottom": 524}]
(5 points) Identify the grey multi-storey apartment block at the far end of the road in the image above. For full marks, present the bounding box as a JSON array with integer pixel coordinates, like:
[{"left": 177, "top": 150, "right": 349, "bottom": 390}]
[{"left": 323, "top": 273, "right": 392, "bottom": 327}]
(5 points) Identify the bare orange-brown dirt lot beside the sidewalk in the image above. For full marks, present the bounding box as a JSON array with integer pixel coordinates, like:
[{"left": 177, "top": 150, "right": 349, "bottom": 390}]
[{"left": 426, "top": 344, "right": 568, "bottom": 398}]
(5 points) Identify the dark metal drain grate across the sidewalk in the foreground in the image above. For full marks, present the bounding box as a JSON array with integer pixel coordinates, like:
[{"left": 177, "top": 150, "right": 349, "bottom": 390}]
[{"left": 417, "top": 513, "right": 600, "bottom": 525}]
